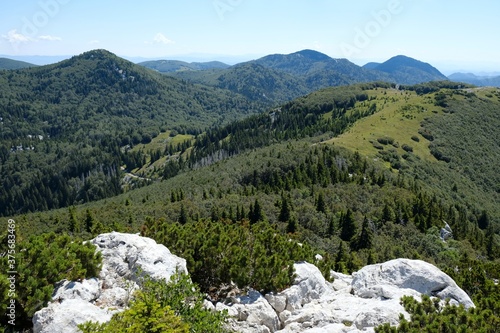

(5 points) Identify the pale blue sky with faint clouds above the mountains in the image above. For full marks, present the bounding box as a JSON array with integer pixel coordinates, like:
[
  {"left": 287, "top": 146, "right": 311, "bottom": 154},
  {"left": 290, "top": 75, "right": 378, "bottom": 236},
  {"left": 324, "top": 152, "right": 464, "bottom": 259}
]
[{"left": 0, "top": 0, "right": 500, "bottom": 74}]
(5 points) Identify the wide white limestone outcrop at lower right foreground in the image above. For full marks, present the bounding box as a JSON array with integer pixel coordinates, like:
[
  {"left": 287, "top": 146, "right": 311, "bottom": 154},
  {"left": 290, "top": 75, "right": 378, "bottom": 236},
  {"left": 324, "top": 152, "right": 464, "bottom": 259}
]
[{"left": 221, "top": 259, "right": 474, "bottom": 333}]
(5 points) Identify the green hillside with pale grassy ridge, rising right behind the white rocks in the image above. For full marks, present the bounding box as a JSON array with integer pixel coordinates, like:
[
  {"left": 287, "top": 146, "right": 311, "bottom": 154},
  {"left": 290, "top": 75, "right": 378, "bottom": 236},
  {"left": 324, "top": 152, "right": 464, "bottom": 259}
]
[{"left": 0, "top": 82, "right": 500, "bottom": 330}]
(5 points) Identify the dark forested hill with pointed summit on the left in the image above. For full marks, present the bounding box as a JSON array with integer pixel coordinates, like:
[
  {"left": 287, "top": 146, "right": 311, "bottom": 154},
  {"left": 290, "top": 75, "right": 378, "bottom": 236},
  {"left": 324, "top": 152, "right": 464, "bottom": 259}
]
[{"left": 0, "top": 50, "right": 266, "bottom": 215}]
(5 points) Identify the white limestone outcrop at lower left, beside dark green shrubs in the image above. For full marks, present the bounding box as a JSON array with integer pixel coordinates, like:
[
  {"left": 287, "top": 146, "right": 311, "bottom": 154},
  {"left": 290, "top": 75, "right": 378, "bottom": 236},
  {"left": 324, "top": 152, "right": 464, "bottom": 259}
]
[{"left": 33, "top": 232, "right": 187, "bottom": 333}]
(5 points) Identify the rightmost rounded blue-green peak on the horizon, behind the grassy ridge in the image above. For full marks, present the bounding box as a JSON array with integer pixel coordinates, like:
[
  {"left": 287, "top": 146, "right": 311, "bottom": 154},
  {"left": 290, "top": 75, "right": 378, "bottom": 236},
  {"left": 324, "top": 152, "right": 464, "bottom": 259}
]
[{"left": 374, "top": 55, "right": 448, "bottom": 84}]
